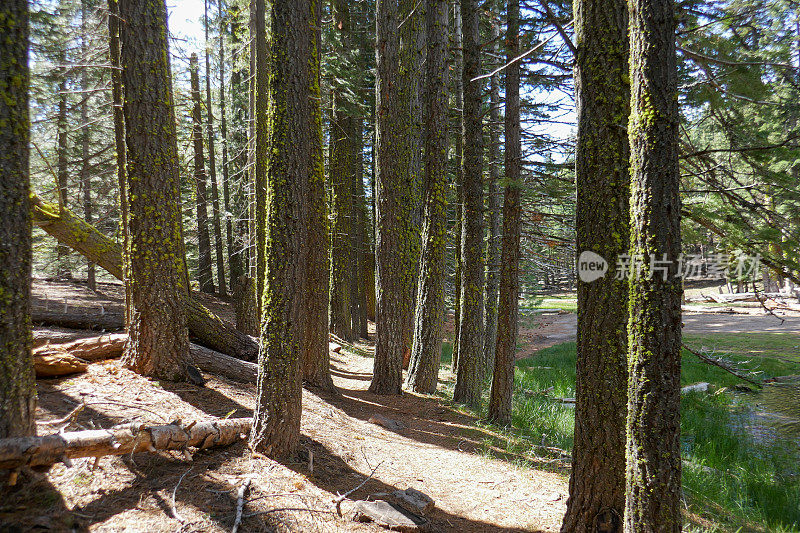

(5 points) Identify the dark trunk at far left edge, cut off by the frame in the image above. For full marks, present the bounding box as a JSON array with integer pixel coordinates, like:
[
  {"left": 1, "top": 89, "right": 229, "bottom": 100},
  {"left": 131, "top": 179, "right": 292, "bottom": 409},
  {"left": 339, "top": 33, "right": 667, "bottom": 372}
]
[{"left": 0, "top": 0, "right": 36, "bottom": 438}]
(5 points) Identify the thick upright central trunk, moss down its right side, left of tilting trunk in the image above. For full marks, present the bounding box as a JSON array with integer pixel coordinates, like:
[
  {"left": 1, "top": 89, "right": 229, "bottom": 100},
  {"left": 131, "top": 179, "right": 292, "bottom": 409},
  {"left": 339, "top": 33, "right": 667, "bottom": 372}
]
[{"left": 369, "top": 0, "right": 418, "bottom": 394}]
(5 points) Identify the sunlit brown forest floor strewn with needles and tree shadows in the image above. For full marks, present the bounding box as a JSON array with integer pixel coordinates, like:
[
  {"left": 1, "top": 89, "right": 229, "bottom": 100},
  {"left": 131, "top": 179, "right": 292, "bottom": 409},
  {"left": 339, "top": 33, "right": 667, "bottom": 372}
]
[{"left": 0, "top": 280, "right": 568, "bottom": 532}]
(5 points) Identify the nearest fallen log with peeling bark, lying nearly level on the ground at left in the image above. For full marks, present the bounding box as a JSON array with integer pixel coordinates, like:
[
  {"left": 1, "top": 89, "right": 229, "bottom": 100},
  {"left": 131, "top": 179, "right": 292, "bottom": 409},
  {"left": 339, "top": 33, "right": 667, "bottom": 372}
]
[{"left": 0, "top": 418, "right": 252, "bottom": 469}]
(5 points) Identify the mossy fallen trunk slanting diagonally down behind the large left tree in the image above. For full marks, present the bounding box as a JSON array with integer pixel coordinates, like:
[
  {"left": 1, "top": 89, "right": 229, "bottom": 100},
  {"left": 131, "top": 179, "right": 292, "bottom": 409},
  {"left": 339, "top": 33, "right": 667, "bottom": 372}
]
[{"left": 31, "top": 194, "right": 258, "bottom": 361}]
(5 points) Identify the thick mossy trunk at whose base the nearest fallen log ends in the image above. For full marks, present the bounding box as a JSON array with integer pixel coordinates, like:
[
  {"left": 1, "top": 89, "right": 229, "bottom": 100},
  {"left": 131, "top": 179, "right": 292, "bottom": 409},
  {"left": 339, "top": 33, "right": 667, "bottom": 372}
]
[{"left": 250, "top": 0, "right": 314, "bottom": 458}]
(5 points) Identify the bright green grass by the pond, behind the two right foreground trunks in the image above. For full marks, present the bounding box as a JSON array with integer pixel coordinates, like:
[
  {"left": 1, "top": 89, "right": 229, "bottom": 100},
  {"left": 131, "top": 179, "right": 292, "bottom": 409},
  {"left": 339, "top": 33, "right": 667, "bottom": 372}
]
[{"left": 446, "top": 333, "right": 800, "bottom": 532}]
